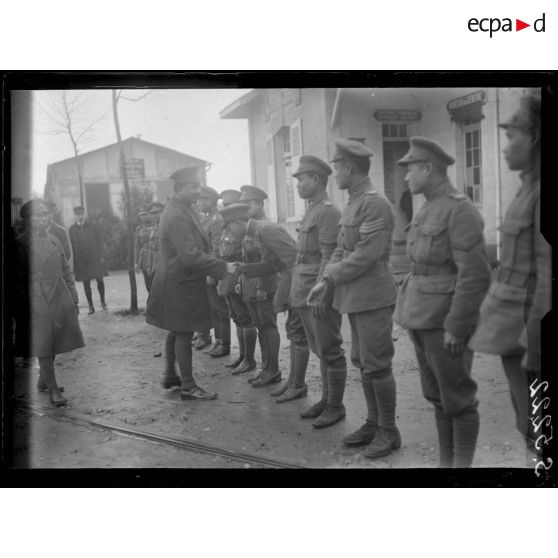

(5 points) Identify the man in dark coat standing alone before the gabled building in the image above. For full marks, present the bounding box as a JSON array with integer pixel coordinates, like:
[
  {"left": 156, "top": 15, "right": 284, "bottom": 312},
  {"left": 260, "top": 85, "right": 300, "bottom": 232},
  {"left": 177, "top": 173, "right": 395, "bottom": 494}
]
[{"left": 69, "top": 206, "right": 108, "bottom": 314}]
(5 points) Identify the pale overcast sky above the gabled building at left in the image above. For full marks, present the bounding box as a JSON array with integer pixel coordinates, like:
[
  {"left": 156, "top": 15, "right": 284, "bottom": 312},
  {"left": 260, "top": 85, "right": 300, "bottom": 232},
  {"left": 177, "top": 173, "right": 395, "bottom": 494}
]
[{"left": 32, "top": 89, "right": 250, "bottom": 196}]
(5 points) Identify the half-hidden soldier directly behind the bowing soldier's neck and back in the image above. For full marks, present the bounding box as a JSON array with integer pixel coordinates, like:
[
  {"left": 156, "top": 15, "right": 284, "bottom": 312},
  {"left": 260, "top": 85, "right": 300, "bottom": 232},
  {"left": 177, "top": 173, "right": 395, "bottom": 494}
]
[{"left": 239, "top": 185, "right": 281, "bottom": 387}]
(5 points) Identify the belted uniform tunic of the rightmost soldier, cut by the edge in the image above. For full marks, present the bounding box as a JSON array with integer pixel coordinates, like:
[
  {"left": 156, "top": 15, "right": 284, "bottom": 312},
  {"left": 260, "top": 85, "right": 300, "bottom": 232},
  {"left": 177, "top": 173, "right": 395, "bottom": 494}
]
[{"left": 471, "top": 173, "right": 551, "bottom": 370}]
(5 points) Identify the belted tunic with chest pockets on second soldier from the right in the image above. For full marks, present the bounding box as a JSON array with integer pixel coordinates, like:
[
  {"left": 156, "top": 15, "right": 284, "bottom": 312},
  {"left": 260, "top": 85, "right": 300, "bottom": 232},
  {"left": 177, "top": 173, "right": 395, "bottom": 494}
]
[{"left": 393, "top": 180, "right": 490, "bottom": 338}]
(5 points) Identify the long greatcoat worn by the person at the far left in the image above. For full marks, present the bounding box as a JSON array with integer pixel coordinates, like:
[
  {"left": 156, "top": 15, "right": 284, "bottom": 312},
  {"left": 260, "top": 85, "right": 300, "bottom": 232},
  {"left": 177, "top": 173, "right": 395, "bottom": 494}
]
[{"left": 16, "top": 230, "right": 85, "bottom": 357}]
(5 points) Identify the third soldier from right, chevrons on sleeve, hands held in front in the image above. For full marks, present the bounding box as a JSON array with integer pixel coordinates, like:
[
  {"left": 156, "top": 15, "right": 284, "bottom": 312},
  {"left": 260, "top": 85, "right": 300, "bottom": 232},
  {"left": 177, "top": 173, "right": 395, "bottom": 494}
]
[{"left": 308, "top": 139, "right": 401, "bottom": 458}]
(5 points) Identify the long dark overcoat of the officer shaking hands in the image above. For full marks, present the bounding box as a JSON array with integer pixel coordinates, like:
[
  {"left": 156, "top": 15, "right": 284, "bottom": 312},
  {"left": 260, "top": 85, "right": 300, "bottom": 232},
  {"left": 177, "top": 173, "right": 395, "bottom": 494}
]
[{"left": 146, "top": 196, "right": 231, "bottom": 333}]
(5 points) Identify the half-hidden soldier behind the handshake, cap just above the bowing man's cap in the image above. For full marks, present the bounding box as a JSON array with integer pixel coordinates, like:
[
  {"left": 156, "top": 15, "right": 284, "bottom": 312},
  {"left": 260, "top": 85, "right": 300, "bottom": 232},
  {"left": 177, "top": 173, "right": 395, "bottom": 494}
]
[{"left": 217, "top": 190, "right": 257, "bottom": 376}]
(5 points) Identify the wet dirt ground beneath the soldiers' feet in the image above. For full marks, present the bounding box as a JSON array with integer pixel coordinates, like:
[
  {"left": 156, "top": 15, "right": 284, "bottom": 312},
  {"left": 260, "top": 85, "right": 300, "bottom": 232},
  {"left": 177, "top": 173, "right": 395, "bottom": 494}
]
[{"left": 10, "top": 272, "right": 527, "bottom": 468}]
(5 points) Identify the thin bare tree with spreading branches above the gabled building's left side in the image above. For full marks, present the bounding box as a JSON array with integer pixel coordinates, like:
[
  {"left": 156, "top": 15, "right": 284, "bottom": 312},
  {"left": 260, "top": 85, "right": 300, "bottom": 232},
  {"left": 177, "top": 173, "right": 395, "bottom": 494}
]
[{"left": 37, "top": 90, "right": 110, "bottom": 205}]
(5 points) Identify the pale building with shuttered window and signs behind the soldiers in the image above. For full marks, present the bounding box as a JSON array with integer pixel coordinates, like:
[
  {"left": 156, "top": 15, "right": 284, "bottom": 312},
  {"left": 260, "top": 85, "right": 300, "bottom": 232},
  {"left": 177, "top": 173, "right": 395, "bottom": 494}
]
[{"left": 221, "top": 87, "right": 540, "bottom": 258}]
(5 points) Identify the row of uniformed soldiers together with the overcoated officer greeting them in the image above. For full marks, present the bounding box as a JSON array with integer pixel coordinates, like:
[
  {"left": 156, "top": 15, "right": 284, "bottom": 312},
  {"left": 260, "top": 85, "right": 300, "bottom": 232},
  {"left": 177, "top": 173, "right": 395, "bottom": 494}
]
[{"left": 146, "top": 94, "right": 550, "bottom": 467}]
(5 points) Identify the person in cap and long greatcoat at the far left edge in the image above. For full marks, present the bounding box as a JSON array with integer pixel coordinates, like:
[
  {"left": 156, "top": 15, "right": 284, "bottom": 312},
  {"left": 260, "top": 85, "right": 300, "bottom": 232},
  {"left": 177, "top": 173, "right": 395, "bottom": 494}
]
[{"left": 15, "top": 200, "right": 85, "bottom": 407}]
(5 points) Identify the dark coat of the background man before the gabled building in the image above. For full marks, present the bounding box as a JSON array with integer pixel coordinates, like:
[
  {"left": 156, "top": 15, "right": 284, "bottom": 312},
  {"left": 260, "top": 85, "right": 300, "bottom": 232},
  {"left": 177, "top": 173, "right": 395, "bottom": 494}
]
[{"left": 68, "top": 221, "right": 108, "bottom": 281}]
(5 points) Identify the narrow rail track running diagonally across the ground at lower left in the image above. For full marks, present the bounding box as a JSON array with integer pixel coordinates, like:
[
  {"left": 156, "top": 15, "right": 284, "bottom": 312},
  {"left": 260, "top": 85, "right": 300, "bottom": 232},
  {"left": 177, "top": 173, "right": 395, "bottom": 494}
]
[{"left": 14, "top": 399, "right": 305, "bottom": 469}]
